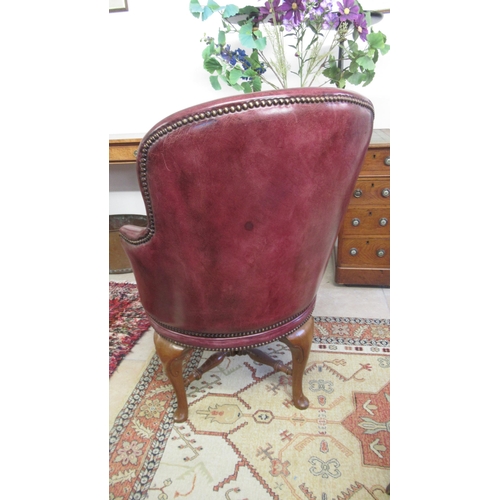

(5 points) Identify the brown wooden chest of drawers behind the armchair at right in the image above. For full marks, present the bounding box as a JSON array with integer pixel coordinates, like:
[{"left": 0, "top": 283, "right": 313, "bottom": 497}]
[{"left": 335, "top": 129, "right": 391, "bottom": 286}]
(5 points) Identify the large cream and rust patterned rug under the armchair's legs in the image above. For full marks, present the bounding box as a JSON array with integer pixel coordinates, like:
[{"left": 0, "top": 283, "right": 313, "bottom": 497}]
[{"left": 109, "top": 317, "right": 390, "bottom": 500}]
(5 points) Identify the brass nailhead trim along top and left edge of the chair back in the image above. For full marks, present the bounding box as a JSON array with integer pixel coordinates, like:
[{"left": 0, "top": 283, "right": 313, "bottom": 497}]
[{"left": 120, "top": 95, "right": 375, "bottom": 245}]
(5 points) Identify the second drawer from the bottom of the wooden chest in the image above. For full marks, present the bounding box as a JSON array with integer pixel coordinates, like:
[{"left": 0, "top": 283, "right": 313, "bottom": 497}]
[{"left": 342, "top": 207, "right": 390, "bottom": 236}]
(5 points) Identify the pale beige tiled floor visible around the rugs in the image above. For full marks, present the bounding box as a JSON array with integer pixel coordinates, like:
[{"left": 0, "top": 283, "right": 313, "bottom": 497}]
[{"left": 109, "top": 256, "right": 390, "bottom": 428}]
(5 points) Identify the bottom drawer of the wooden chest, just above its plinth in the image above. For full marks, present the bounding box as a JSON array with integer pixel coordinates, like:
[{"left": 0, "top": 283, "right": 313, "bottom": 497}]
[{"left": 337, "top": 236, "right": 390, "bottom": 268}]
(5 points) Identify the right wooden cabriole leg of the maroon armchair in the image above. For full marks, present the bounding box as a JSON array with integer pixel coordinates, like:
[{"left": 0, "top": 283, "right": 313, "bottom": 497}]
[{"left": 282, "top": 317, "right": 314, "bottom": 410}]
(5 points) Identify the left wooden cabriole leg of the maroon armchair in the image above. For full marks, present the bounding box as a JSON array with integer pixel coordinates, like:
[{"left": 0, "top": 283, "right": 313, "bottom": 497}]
[{"left": 154, "top": 332, "right": 192, "bottom": 422}]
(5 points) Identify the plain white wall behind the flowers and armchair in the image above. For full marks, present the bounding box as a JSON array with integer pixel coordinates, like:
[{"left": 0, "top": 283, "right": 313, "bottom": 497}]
[{"left": 108, "top": 0, "right": 391, "bottom": 214}]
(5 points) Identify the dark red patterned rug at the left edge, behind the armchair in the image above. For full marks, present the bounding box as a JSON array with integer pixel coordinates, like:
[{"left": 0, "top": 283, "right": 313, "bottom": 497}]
[{"left": 109, "top": 281, "right": 151, "bottom": 376}]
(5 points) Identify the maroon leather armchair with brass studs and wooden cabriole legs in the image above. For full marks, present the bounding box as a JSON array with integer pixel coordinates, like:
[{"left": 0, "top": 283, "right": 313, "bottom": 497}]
[{"left": 120, "top": 88, "right": 374, "bottom": 422}]
